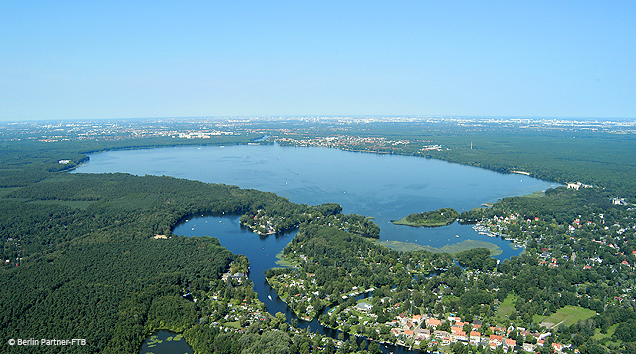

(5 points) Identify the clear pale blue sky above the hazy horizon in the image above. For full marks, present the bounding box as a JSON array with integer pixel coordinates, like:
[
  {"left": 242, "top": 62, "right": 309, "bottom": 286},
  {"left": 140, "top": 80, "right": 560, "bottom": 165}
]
[{"left": 0, "top": 0, "right": 636, "bottom": 121}]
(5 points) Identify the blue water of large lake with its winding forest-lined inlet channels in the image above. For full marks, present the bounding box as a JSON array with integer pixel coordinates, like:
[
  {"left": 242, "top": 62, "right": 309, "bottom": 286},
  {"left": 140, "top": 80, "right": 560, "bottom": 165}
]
[{"left": 75, "top": 145, "right": 557, "bottom": 353}]
